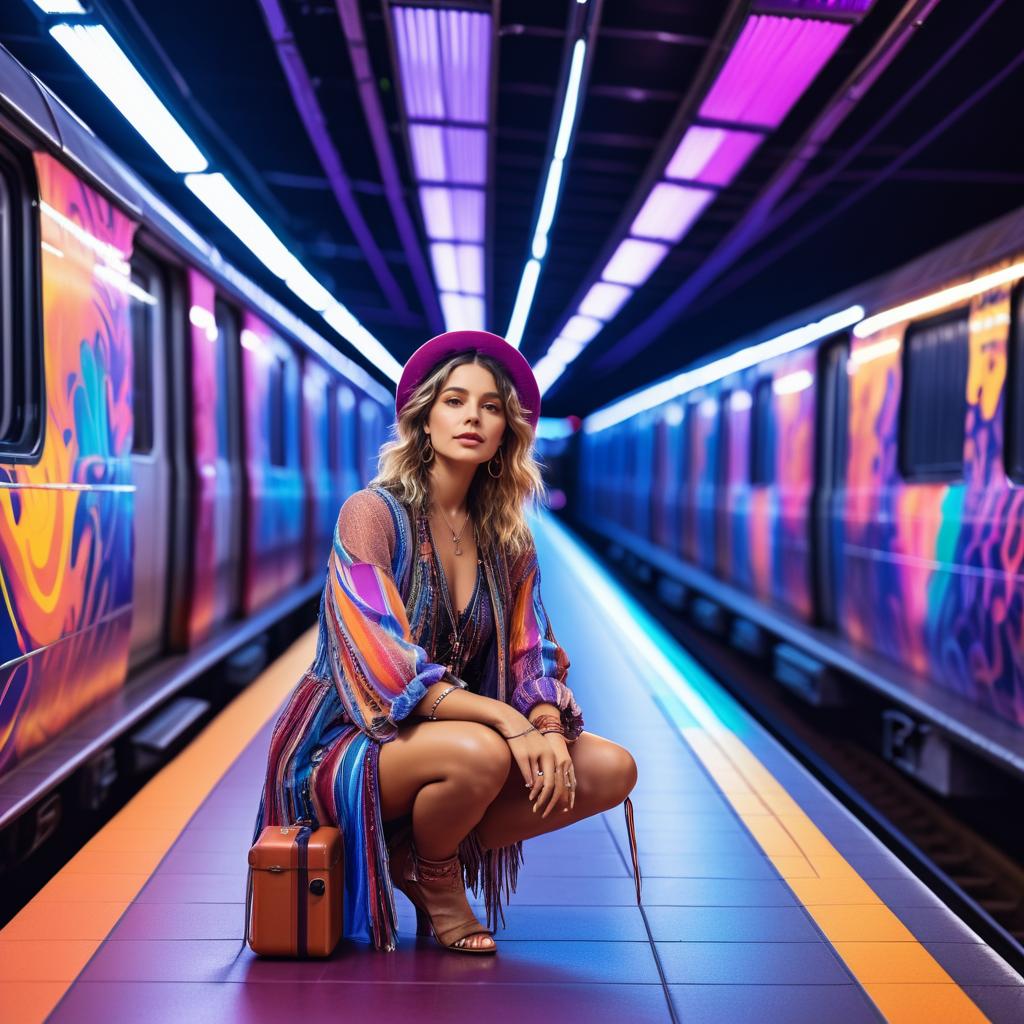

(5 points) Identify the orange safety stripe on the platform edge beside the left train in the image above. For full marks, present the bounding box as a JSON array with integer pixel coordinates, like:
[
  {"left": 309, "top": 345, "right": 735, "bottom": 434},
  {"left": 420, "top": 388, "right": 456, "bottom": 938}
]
[{"left": 0, "top": 627, "right": 316, "bottom": 1024}]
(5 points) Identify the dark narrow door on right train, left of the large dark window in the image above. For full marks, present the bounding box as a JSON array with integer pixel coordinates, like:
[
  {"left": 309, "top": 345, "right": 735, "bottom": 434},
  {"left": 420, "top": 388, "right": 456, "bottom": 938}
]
[{"left": 811, "top": 335, "right": 850, "bottom": 626}]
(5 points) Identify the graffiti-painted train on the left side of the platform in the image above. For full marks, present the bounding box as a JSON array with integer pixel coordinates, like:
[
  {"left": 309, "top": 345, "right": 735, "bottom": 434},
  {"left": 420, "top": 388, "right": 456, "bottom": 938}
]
[{"left": 0, "top": 49, "right": 392, "bottom": 860}]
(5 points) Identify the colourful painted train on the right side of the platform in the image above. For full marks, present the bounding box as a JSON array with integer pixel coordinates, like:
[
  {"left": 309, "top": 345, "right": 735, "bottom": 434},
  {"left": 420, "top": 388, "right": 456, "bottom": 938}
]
[{"left": 570, "top": 211, "right": 1024, "bottom": 792}]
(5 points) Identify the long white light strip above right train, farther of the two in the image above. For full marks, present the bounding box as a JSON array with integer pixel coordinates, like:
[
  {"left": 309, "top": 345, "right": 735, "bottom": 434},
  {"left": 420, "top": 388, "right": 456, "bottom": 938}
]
[{"left": 584, "top": 306, "right": 864, "bottom": 433}]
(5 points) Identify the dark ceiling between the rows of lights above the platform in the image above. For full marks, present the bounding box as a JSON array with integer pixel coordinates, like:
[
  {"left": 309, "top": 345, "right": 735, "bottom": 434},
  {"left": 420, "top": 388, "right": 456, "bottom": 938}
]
[{"left": 0, "top": 0, "right": 1024, "bottom": 416}]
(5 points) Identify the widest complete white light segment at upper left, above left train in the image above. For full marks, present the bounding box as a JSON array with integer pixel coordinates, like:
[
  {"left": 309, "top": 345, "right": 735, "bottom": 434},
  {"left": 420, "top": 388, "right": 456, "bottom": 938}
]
[{"left": 50, "top": 24, "right": 208, "bottom": 174}]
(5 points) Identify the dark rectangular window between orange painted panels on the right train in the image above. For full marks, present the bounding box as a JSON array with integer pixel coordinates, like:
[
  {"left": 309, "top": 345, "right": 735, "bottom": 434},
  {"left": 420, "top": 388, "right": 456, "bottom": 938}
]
[{"left": 900, "top": 309, "right": 968, "bottom": 480}]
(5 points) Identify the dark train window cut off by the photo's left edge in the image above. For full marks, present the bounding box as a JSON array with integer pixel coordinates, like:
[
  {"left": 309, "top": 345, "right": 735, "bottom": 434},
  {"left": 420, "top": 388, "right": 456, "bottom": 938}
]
[{"left": 0, "top": 148, "right": 43, "bottom": 462}]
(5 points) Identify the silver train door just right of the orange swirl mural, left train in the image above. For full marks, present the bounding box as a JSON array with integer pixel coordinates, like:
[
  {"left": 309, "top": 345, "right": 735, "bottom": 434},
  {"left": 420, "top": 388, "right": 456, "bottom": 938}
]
[{"left": 129, "top": 252, "right": 172, "bottom": 670}]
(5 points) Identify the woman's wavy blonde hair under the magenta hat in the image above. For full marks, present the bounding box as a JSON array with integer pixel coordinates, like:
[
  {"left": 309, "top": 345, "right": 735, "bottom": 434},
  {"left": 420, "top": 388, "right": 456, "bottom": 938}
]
[{"left": 370, "top": 348, "right": 548, "bottom": 557}]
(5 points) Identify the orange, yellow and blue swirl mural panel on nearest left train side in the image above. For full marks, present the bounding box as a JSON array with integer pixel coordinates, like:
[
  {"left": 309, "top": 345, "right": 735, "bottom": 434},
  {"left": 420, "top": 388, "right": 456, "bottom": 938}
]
[{"left": 0, "top": 154, "right": 135, "bottom": 773}]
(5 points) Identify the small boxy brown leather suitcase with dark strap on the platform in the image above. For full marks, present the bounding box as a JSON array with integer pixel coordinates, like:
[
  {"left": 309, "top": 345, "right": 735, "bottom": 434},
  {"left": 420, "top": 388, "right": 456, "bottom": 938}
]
[{"left": 248, "top": 823, "right": 345, "bottom": 958}]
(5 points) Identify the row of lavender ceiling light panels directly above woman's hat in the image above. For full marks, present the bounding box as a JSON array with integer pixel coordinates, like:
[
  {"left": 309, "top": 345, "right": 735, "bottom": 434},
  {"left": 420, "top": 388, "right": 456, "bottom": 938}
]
[{"left": 390, "top": 5, "right": 493, "bottom": 330}]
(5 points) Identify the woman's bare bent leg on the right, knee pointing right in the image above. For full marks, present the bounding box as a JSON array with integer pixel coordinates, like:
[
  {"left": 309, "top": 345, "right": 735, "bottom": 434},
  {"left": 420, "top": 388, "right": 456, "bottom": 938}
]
[{"left": 476, "top": 732, "right": 637, "bottom": 850}]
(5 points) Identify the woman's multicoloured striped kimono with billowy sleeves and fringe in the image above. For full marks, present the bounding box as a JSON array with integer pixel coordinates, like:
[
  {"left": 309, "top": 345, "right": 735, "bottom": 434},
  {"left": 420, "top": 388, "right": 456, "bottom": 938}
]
[{"left": 247, "top": 487, "right": 583, "bottom": 949}]
